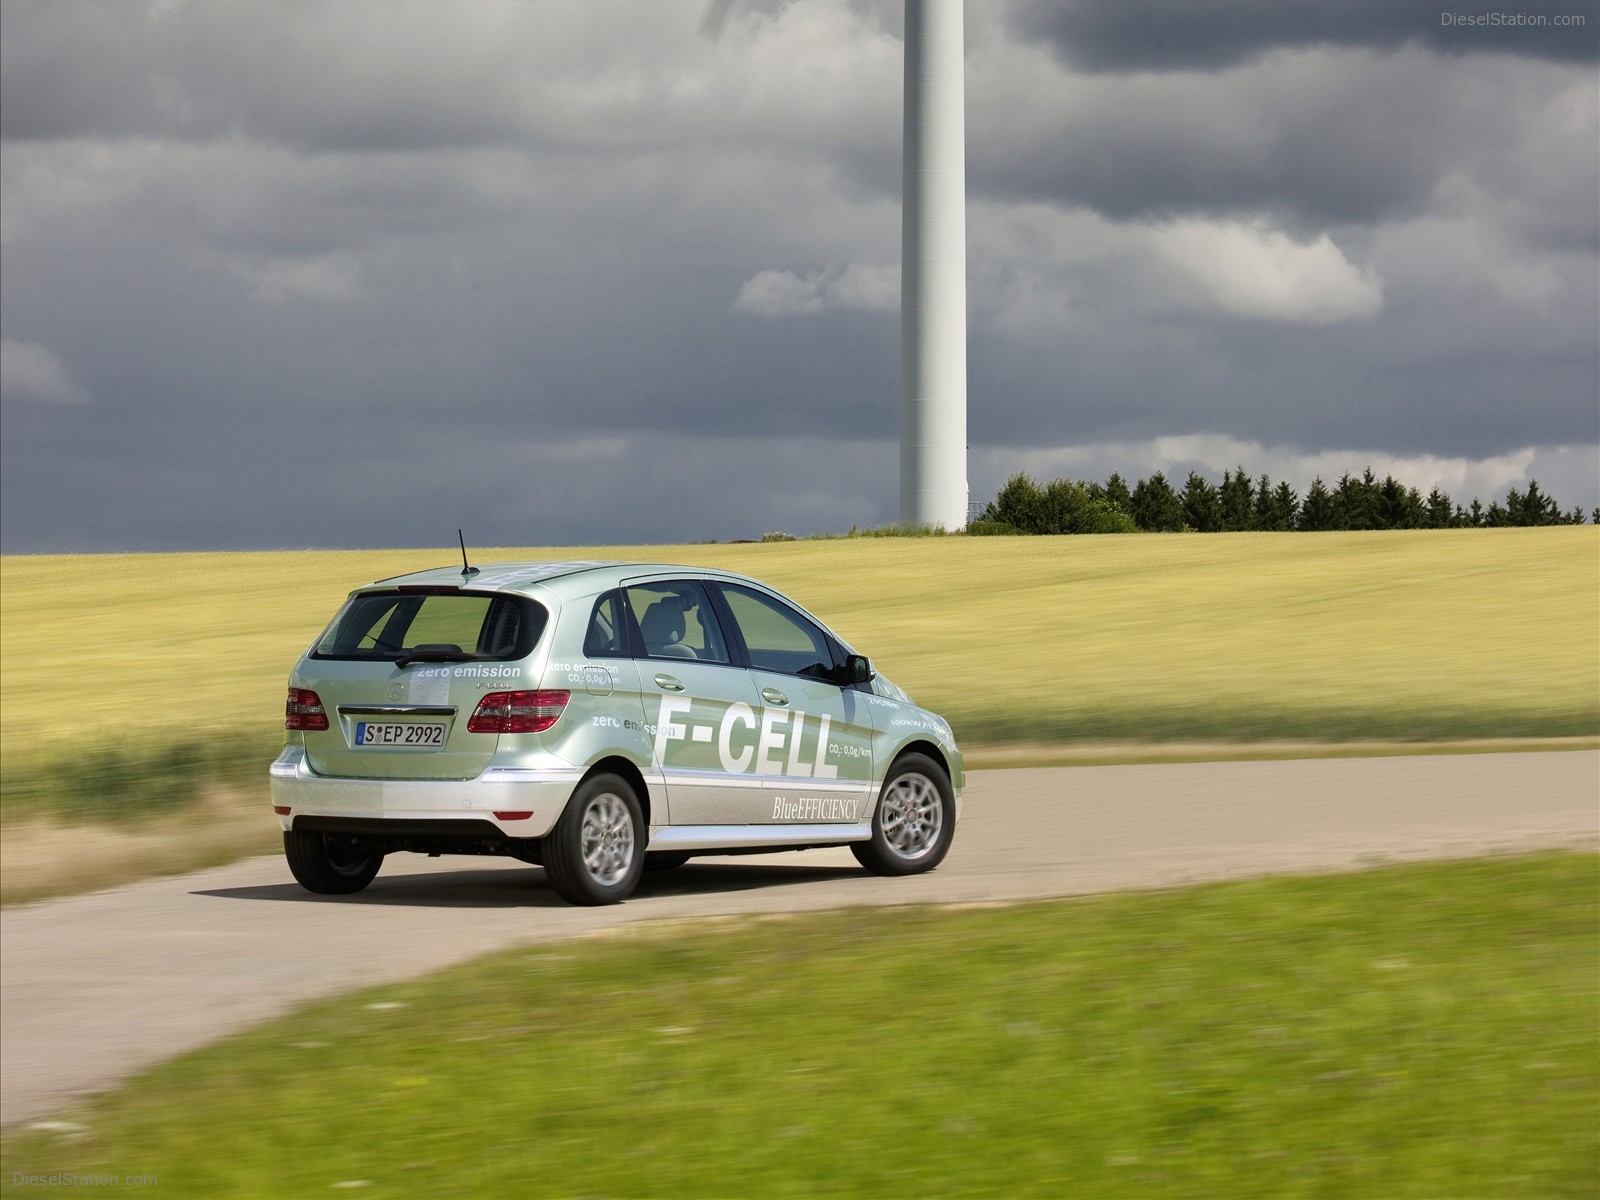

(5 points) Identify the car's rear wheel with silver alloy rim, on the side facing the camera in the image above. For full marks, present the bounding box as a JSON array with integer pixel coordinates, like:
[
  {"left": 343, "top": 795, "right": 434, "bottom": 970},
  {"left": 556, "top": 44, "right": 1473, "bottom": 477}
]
[{"left": 544, "top": 774, "right": 646, "bottom": 904}]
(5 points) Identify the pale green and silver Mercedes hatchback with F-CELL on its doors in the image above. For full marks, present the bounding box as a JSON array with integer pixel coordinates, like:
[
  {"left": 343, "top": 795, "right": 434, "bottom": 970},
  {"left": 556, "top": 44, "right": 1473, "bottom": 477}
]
[{"left": 272, "top": 562, "right": 965, "bottom": 904}]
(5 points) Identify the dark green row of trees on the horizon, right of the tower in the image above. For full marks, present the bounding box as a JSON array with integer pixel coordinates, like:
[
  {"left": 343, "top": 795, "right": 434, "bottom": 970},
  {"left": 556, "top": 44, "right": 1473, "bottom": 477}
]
[{"left": 966, "top": 467, "right": 1600, "bottom": 534}]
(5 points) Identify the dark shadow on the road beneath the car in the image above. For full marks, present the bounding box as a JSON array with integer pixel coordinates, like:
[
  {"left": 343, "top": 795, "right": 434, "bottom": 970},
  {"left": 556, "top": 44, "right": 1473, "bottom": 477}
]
[{"left": 189, "top": 861, "right": 870, "bottom": 909}]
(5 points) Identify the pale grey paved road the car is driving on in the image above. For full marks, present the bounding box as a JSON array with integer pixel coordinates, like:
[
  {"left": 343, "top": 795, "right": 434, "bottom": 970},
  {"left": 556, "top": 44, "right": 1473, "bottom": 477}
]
[{"left": 0, "top": 750, "right": 1600, "bottom": 1125}]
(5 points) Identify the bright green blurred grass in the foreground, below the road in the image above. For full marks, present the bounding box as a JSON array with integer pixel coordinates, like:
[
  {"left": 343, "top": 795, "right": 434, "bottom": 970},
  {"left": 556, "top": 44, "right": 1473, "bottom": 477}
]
[{"left": 3, "top": 854, "right": 1600, "bottom": 1200}]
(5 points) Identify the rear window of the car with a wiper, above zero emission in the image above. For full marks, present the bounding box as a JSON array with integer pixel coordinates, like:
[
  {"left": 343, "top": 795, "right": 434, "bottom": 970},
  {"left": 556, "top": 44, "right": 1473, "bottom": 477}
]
[{"left": 312, "top": 589, "right": 549, "bottom": 662}]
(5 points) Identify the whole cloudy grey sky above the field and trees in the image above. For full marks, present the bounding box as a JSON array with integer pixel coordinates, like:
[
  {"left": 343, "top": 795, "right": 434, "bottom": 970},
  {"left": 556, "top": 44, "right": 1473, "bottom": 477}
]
[{"left": 0, "top": 0, "right": 1600, "bottom": 552}]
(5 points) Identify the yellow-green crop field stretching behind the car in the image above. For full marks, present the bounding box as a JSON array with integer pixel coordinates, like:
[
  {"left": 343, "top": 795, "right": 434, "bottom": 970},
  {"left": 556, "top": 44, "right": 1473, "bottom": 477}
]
[{"left": 0, "top": 526, "right": 1600, "bottom": 766}]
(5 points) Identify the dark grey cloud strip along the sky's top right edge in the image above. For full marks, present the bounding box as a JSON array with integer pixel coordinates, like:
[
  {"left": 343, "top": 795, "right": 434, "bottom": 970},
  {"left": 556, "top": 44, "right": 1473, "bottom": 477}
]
[{"left": 1011, "top": 0, "right": 1600, "bottom": 72}]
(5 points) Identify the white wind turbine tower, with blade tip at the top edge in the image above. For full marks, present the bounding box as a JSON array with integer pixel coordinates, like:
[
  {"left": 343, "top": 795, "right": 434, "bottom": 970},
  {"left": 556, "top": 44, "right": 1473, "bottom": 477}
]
[{"left": 701, "top": 0, "right": 966, "bottom": 530}]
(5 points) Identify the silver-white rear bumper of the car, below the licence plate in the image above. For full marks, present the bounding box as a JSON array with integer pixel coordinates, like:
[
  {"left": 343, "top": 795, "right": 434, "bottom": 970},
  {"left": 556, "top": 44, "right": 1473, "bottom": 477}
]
[{"left": 270, "top": 746, "right": 582, "bottom": 838}]
